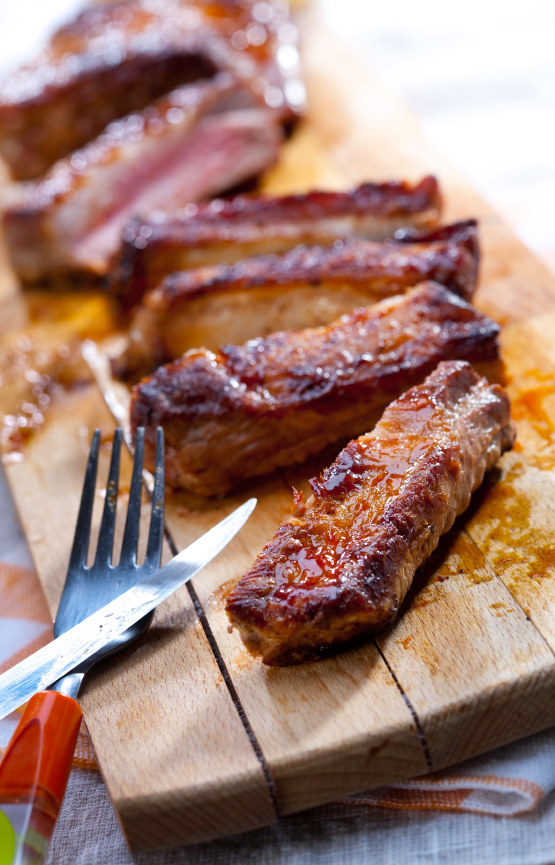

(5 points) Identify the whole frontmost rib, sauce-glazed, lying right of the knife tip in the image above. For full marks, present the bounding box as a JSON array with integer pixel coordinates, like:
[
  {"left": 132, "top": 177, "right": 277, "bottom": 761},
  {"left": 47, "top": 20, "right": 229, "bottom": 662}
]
[{"left": 227, "top": 361, "right": 515, "bottom": 665}]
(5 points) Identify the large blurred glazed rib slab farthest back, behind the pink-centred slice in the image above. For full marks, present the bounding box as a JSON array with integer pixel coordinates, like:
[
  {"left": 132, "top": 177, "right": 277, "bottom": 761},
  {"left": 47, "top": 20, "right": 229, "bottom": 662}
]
[{"left": 0, "top": 0, "right": 304, "bottom": 179}]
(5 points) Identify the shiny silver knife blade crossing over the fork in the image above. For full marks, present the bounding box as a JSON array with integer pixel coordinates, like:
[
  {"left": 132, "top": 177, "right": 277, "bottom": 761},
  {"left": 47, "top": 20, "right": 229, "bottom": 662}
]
[{"left": 0, "top": 498, "right": 256, "bottom": 719}]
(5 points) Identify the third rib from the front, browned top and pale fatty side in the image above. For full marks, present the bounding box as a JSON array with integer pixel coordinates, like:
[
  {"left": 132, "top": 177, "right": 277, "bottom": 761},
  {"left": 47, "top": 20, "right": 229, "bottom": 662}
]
[{"left": 114, "top": 221, "right": 478, "bottom": 381}]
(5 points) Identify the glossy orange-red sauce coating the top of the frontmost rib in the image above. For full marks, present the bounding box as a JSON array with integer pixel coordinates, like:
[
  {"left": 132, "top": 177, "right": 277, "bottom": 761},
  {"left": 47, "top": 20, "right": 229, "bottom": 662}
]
[{"left": 273, "top": 392, "right": 452, "bottom": 601}]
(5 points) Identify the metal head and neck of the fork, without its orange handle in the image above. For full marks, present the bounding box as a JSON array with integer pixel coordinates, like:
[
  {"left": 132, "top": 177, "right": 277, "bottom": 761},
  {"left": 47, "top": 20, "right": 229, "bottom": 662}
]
[{"left": 49, "top": 427, "right": 164, "bottom": 699}]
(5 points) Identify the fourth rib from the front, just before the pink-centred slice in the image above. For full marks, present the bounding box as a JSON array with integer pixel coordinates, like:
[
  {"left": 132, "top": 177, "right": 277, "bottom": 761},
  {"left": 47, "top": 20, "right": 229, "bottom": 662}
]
[{"left": 114, "top": 177, "right": 441, "bottom": 308}]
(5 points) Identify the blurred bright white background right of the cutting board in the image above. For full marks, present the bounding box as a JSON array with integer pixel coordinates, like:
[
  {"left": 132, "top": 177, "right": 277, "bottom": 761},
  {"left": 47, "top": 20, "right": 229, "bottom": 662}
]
[{"left": 320, "top": 0, "right": 555, "bottom": 271}]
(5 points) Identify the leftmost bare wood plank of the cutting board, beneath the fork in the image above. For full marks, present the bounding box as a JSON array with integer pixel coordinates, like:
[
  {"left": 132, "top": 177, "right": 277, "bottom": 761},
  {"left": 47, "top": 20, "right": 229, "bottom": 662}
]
[{"left": 2, "top": 386, "right": 276, "bottom": 849}]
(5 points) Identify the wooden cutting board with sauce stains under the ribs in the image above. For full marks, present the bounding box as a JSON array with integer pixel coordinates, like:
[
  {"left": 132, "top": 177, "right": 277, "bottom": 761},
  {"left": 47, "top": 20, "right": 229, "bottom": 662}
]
[{"left": 0, "top": 11, "right": 555, "bottom": 850}]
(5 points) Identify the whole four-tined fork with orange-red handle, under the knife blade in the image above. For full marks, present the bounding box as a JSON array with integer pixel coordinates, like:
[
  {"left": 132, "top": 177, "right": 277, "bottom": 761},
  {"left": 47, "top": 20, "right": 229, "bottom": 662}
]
[{"left": 0, "top": 427, "right": 164, "bottom": 865}]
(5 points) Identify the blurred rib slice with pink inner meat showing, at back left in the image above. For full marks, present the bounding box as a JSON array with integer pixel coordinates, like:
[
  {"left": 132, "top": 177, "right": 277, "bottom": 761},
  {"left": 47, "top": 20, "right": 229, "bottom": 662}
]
[{"left": 3, "top": 73, "right": 281, "bottom": 282}]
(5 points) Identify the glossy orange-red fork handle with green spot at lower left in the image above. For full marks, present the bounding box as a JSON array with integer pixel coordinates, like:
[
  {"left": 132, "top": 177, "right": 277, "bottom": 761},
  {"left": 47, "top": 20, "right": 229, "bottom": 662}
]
[{"left": 0, "top": 691, "right": 82, "bottom": 865}]
